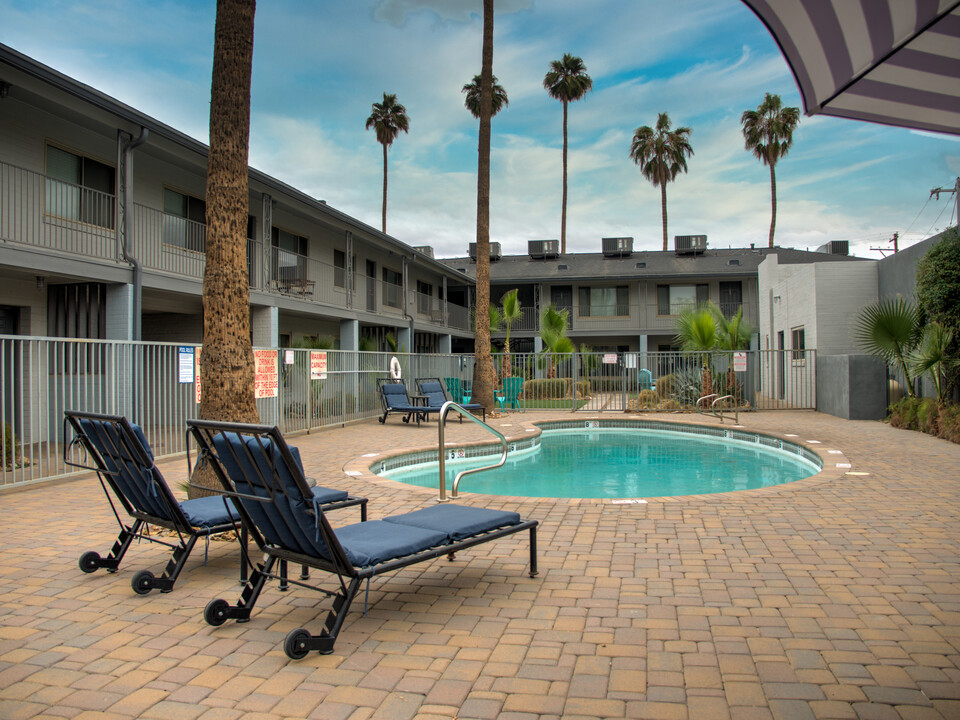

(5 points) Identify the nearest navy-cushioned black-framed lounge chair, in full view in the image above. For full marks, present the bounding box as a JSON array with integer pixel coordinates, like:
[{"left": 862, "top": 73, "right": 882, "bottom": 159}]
[{"left": 187, "top": 420, "right": 537, "bottom": 659}]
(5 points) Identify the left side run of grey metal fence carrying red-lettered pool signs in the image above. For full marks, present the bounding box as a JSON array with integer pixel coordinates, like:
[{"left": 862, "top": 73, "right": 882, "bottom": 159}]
[{"left": 0, "top": 336, "right": 473, "bottom": 487}]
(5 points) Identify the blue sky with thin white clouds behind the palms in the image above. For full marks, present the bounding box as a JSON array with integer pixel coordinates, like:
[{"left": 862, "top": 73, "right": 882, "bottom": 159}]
[{"left": 0, "top": 0, "right": 960, "bottom": 257}]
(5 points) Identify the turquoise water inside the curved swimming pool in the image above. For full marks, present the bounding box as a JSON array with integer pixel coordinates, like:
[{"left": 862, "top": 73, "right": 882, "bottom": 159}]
[{"left": 380, "top": 429, "right": 820, "bottom": 498}]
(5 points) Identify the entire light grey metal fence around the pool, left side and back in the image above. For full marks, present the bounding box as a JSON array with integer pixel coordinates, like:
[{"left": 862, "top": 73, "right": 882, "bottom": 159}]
[{"left": 0, "top": 336, "right": 816, "bottom": 487}]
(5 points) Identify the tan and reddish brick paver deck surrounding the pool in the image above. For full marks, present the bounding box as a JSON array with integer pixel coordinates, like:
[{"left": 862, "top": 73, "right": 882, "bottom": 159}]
[{"left": 0, "top": 412, "right": 960, "bottom": 720}]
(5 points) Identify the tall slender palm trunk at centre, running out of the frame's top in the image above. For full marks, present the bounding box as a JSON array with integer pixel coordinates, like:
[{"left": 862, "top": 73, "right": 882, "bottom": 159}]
[{"left": 471, "top": 0, "right": 494, "bottom": 411}]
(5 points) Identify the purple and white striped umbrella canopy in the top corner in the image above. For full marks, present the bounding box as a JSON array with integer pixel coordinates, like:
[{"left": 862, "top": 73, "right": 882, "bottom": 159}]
[{"left": 743, "top": 0, "right": 960, "bottom": 134}]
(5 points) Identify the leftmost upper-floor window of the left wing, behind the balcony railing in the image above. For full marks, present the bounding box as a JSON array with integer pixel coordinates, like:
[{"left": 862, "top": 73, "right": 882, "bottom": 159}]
[{"left": 45, "top": 145, "right": 116, "bottom": 229}]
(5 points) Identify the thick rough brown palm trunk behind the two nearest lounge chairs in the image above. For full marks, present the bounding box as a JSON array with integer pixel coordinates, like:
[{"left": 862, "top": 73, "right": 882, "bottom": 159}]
[{"left": 190, "top": 0, "right": 260, "bottom": 495}]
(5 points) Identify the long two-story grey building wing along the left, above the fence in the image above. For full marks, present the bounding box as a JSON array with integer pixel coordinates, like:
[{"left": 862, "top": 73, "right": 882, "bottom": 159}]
[{"left": 0, "top": 45, "right": 473, "bottom": 352}]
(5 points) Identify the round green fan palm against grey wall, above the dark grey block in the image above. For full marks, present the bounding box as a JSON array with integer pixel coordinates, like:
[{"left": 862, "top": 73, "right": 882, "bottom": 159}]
[{"left": 854, "top": 297, "right": 923, "bottom": 397}]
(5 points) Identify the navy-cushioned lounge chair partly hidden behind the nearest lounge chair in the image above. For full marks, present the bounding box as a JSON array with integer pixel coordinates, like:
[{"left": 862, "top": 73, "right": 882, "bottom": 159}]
[{"left": 63, "top": 410, "right": 367, "bottom": 595}]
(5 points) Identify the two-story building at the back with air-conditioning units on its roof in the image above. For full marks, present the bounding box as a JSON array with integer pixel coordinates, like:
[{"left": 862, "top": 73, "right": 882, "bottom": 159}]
[{"left": 444, "top": 235, "right": 857, "bottom": 353}]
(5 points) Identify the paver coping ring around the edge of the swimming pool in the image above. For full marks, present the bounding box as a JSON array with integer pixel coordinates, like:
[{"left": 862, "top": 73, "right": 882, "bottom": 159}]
[{"left": 342, "top": 416, "right": 863, "bottom": 506}]
